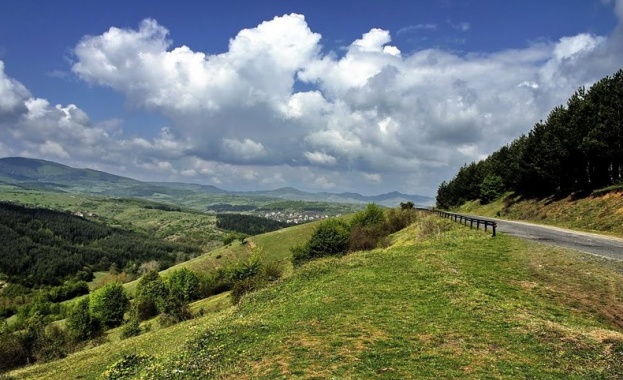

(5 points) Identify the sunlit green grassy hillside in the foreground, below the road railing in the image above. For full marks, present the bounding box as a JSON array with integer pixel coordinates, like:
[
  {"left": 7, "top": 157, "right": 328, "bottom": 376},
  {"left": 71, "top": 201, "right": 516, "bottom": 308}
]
[{"left": 10, "top": 216, "right": 623, "bottom": 379}]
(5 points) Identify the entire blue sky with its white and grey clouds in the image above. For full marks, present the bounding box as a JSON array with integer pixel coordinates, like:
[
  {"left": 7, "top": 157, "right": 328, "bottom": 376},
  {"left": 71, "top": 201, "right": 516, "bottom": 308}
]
[{"left": 0, "top": 0, "right": 623, "bottom": 196}]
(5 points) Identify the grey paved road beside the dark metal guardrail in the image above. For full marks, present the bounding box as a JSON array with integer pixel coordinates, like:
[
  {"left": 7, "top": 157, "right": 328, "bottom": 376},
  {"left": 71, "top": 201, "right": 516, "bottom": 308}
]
[{"left": 478, "top": 216, "right": 623, "bottom": 260}]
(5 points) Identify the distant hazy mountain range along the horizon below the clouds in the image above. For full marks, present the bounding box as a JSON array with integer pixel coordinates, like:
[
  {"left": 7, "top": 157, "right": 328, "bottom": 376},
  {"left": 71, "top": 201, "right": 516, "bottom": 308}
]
[{"left": 0, "top": 157, "right": 434, "bottom": 207}]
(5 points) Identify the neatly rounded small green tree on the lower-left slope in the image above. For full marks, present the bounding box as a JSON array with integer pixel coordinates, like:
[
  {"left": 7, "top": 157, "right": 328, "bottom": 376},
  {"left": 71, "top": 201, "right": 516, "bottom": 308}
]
[{"left": 90, "top": 282, "right": 130, "bottom": 328}]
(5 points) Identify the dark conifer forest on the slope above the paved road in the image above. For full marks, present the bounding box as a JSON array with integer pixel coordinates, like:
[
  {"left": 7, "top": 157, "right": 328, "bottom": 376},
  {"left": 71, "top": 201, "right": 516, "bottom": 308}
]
[{"left": 437, "top": 69, "right": 623, "bottom": 209}]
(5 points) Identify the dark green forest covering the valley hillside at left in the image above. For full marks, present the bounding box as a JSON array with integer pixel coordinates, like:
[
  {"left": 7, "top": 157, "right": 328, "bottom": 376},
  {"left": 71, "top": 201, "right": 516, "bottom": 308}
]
[{"left": 0, "top": 202, "right": 198, "bottom": 288}]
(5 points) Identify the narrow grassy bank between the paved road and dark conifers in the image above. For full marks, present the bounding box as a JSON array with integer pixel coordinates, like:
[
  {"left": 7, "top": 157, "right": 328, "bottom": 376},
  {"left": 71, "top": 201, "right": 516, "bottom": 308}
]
[{"left": 457, "top": 191, "right": 623, "bottom": 236}]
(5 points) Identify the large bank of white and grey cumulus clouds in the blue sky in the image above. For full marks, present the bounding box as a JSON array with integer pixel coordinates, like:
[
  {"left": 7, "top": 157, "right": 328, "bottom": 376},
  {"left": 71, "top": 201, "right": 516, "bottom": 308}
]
[{"left": 0, "top": 8, "right": 623, "bottom": 194}]
